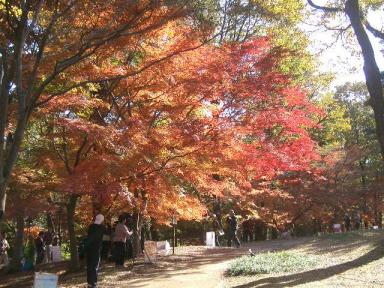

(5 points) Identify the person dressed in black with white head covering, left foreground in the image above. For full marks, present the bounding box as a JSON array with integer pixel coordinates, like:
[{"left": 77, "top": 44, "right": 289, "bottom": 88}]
[{"left": 86, "top": 214, "right": 104, "bottom": 288}]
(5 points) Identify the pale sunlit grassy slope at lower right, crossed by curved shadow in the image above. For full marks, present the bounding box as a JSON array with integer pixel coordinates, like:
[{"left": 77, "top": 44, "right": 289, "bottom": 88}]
[{"left": 223, "top": 231, "right": 384, "bottom": 288}]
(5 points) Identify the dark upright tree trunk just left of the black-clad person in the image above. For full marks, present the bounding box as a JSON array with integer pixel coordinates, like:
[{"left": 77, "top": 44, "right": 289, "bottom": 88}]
[{"left": 67, "top": 195, "right": 80, "bottom": 271}]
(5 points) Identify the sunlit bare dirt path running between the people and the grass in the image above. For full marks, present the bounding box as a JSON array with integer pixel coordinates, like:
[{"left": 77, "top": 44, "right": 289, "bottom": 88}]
[{"left": 96, "top": 238, "right": 307, "bottom": 288}]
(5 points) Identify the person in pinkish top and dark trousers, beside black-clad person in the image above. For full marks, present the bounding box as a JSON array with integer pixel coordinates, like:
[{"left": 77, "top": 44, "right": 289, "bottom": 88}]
[{"left": 113, "top": 215, "right": 132, "bottom": 266}]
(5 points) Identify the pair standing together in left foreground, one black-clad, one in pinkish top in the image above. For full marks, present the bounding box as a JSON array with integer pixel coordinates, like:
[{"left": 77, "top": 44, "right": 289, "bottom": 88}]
[{"left": 85, "top": 214, "right": 133, "bottom": 288}]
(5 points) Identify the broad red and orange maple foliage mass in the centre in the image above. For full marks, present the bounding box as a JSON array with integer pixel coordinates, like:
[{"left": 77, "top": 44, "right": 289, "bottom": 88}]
[{"left": 17, "top": 27, "right": 317, "bottom": 260}]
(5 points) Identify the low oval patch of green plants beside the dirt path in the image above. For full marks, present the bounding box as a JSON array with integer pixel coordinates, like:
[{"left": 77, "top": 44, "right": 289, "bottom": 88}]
[{"left": 226, "top": 251, "right": 318, "bottom": 276}]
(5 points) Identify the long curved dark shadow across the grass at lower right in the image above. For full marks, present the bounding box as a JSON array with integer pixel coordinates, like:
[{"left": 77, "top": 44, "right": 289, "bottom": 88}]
[{"left": 231, "top": 245, "right": 384, "bottom": 288}]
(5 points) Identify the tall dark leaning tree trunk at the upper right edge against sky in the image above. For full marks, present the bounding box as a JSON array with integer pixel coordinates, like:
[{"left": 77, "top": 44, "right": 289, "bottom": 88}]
[{"left": 345, "top": 0, "right": 384, "bottom": 158}]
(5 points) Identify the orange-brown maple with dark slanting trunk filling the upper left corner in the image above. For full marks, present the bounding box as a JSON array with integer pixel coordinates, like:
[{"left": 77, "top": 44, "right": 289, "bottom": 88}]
[{"left": 0, "top": 0, "right": 212, "bottom": 220}]
